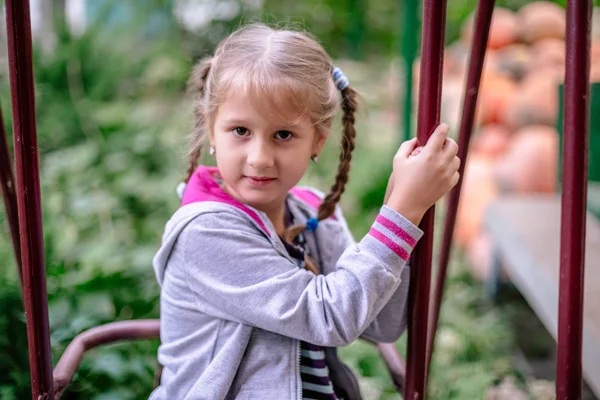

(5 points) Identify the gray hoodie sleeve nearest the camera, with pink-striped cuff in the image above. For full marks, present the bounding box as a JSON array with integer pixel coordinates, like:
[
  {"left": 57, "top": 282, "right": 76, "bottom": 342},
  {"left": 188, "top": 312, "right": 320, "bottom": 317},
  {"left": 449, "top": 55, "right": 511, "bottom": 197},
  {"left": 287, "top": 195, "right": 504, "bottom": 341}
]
[{"left": 179, "top": 209, "right": 421, "bottom": 346}]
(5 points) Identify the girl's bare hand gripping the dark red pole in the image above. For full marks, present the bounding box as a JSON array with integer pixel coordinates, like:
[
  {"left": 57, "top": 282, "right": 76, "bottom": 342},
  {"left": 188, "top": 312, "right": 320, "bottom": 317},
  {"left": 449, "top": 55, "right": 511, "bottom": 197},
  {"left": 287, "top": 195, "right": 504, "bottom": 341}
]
[{"left": 385, "top": 124, "right": 460, "bottom": 225}]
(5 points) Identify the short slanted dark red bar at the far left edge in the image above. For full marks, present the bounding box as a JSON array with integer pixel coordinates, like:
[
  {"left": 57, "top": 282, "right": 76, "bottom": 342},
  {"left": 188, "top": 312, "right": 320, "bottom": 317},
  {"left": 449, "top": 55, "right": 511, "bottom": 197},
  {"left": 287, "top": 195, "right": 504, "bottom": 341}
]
[{"left": 0, "top": 103, "right": 23, "bottom": 287}]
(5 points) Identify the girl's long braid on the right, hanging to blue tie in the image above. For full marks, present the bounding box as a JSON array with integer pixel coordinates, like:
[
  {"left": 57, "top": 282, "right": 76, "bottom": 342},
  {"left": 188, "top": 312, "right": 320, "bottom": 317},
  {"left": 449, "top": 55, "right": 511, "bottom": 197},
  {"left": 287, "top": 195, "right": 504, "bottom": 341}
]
[{"left": 282, "top": 86, "right": 358, "bottom": 274}]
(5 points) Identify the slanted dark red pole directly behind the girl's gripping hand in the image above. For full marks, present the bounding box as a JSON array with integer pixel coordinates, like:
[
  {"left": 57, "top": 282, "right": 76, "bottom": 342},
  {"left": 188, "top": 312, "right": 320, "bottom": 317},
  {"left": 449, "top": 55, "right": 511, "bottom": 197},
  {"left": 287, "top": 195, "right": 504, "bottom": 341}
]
[{"left": 427, "top": 0, "right": 496, "bottom": 369}]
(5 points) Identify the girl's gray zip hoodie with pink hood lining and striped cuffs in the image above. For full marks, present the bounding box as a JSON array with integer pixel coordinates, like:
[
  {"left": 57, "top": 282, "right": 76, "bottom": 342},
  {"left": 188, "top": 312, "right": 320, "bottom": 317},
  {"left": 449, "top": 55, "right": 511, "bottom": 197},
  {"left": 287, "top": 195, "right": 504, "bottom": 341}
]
[{"left": 150, "top": 167, "right": 422, "bottom": 400}]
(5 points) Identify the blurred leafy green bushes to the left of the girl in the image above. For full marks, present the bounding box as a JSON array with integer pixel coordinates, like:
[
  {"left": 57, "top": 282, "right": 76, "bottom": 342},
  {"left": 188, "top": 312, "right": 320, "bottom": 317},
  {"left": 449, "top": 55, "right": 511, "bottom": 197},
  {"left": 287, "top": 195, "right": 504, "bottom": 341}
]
[{"left": 0, "top": 10, "right": 191, "bottom": 399}]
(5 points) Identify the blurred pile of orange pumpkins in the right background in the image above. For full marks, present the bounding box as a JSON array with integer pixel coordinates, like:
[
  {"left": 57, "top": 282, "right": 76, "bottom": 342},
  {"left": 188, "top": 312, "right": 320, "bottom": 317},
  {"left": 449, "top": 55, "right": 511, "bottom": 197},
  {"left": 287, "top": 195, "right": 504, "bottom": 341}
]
[{"left": 414, "top": 1, "right": 600, "bottom": 278}]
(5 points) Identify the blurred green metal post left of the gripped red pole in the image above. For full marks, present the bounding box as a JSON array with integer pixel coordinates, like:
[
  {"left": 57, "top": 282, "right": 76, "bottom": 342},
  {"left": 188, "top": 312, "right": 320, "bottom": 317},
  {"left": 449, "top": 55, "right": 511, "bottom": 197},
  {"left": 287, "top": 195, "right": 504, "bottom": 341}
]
[{"left": 402, "top": 0, "right": 419, "bottom": 140}]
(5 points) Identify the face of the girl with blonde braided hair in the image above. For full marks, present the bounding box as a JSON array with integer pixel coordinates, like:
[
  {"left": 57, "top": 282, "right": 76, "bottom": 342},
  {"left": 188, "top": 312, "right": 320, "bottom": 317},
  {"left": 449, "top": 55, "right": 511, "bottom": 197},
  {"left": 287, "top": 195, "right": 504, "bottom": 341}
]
[{"left": 210, "top": 94, "right": 326, "bottom": 213}]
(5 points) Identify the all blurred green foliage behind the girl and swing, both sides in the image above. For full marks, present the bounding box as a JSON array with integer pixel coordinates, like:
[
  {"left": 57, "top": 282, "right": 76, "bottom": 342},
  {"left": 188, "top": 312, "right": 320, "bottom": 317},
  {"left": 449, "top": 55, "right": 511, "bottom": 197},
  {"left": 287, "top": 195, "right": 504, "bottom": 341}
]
[{"left": 0, "top": 0, "right": 576, "bottom": 400}]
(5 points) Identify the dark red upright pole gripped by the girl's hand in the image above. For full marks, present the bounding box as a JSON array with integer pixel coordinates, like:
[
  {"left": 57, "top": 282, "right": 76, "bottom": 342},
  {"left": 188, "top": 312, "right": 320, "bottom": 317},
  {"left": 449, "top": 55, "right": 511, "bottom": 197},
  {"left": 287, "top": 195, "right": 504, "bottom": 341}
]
[{"left": 404, "top": 0, "right": 446, "bottom": 400}]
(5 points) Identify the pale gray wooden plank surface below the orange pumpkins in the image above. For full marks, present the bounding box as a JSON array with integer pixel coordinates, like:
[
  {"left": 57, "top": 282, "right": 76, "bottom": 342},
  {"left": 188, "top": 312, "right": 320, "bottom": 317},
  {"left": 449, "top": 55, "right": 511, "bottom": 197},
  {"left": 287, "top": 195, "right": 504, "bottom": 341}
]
[{"left": 484, "top": 195, "right": 600, "bottom": 396}]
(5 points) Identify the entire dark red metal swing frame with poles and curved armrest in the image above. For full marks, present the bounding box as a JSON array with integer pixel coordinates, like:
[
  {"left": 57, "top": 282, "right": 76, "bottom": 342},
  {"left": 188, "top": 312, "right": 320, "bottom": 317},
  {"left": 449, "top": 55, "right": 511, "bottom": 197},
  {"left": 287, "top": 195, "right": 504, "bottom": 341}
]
[{"left": 0, "top": 0, "right": 592, "bottom": 400}]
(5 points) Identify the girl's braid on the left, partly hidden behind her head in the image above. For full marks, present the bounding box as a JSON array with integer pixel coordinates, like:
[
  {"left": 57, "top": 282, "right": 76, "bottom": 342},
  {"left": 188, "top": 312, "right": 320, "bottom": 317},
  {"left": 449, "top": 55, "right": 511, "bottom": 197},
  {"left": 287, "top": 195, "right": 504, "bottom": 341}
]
[{"left": 186, "top": 57, "right": 212, "bottom": 182}]
